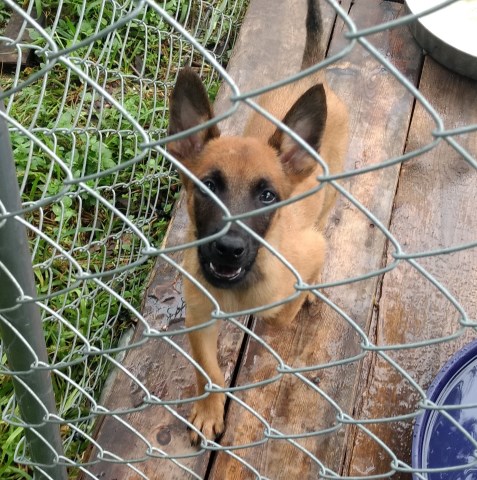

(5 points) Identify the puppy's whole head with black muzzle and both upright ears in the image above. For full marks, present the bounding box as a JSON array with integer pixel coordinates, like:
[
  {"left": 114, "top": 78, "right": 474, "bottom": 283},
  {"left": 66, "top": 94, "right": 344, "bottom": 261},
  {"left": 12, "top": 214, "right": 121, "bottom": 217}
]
[{"left": 168, "top": 69, "right": 326, "bottom": 288}]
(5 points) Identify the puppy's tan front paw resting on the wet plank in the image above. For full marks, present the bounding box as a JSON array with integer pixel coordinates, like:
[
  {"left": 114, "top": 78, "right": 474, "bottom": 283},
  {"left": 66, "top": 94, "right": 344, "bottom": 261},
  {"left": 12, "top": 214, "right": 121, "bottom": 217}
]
[{"left": 189, "top": 393, "right": 225, "bottom": 445}]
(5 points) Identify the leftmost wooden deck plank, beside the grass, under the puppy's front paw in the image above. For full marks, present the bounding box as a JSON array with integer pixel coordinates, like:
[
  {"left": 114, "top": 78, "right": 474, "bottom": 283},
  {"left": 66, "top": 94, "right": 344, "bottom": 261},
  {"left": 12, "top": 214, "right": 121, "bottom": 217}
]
[{"left": 84, "top": 0, "right": 334, "bottom": 480}]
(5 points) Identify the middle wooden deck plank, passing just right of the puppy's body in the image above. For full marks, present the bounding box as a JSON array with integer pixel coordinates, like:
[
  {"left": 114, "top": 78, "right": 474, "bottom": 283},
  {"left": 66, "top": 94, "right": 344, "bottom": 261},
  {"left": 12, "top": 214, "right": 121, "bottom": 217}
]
[{"left": 211, "top": 1, "right": 421, "bottom": 479}]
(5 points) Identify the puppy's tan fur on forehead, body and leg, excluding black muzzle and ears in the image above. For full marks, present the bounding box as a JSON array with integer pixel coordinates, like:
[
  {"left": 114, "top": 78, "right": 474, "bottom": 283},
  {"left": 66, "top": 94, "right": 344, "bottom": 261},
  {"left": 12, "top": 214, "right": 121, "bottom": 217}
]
[{"left": 180, "top": 77, "right": 347, "bottom": 443}]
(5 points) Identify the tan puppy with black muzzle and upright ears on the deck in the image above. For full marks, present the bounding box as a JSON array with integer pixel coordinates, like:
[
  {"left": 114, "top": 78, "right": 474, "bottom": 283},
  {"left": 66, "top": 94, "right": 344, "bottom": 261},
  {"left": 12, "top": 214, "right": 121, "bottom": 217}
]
[{"left": 168, "top": 0, "right": 348, "bottom": 445}]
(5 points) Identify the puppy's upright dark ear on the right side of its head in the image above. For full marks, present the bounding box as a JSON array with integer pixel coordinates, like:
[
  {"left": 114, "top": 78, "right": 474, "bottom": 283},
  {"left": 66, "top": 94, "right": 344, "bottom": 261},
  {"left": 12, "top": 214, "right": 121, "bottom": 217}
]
[{"left": 268, "top": 83, "right": 327, "bottom": 178}]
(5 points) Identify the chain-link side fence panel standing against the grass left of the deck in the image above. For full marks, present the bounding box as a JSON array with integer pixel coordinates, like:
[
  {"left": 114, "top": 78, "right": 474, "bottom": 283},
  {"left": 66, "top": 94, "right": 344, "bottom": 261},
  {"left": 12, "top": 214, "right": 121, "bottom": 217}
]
[{"left": 0, "top": 0, "right": 245, "bottom": 478}]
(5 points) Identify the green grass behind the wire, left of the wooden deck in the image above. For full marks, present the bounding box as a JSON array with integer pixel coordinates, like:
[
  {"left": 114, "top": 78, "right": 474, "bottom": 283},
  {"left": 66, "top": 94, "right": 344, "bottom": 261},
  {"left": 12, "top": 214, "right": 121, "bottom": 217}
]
[{"left": 0, "top": 0, "right": 243, "bottom": 480}]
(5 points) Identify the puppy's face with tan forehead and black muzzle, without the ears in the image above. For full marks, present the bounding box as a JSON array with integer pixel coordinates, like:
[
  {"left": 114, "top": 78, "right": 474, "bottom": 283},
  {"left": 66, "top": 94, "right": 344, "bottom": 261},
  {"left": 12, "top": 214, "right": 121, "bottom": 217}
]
[{"left": 186, "top": 137, "right": 290, "bottom": 288}]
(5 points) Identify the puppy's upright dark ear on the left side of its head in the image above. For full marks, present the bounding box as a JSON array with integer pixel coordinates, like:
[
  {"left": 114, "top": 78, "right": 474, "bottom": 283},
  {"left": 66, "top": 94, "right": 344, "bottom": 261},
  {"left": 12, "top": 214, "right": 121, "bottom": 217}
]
[{"left": 167, "top": 67, "right": 220, "bottom": 160}]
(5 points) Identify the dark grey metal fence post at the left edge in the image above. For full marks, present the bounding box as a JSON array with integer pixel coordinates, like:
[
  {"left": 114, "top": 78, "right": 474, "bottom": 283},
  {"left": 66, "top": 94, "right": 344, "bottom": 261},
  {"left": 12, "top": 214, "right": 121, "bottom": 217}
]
[{"left": 0, "top": 101, "right": 67, "bottom": 480}]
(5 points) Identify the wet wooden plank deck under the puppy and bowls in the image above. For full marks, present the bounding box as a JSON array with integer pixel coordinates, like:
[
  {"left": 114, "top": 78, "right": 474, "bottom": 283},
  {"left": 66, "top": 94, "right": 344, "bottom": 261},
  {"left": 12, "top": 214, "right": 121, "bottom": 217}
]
[{"left": 84, "top": 0, "right": 477, "bottom": 480}]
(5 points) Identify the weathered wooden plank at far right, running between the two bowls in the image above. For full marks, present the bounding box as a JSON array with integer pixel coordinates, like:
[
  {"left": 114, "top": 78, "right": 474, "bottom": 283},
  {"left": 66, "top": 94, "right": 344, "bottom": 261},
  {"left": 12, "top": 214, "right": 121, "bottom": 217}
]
[{"left": 348, "top": 57, "right": 477, "bottom": 478}]
